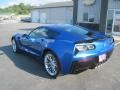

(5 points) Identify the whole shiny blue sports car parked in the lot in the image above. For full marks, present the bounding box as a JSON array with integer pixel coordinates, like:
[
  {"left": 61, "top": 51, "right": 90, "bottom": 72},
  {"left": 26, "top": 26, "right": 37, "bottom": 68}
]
[{"left": 11, "top": 24, "right": 114, "bottom": 77}]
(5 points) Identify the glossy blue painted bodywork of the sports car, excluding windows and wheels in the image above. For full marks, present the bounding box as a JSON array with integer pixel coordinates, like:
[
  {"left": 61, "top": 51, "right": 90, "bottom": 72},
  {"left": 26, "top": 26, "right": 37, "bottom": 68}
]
[{"left": 13, "top": 25, "right": 114, "bottom": 74}]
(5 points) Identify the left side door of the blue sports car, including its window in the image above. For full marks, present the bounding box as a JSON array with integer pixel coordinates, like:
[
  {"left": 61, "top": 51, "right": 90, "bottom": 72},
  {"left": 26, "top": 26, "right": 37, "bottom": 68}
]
[{"left": 21, "top": 28, "right": 48, "bottom": 56}]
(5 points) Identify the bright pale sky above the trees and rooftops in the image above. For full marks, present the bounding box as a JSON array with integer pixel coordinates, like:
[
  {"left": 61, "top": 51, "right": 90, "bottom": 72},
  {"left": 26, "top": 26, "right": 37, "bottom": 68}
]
[{"left": 0, "top": 0, "right": 70, "bottom": 8}]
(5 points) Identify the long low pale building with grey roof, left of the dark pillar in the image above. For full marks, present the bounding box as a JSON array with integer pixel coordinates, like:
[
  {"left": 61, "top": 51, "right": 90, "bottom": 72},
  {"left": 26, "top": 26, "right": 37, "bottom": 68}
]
[{"left": 31, "top": 1, "right": 73, "bottom": 24}]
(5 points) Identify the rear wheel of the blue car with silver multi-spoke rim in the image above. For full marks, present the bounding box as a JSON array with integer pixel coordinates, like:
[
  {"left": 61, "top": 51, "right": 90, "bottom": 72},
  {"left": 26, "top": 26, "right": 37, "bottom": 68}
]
[{"left": 44, "top": 51, "right": 60, "bottom": 78}]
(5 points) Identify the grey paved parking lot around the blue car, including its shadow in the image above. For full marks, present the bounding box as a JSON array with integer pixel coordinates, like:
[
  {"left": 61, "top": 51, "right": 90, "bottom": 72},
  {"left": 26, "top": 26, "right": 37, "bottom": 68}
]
[{"left": 0, "top": 23, "right": 120, "bottom": 90}]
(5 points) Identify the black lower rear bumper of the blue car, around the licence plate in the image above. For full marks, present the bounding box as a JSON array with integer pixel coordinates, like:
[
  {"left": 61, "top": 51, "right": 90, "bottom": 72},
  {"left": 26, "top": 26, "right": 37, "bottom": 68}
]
[{"left": 71, "top": 50, "right": 113, "bottom": 73}]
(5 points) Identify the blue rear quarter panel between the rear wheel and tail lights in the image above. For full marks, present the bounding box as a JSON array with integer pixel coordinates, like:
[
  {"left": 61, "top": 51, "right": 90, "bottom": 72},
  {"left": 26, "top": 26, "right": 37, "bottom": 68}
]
[{"left": 48, "top": 40, "right": 74, "bottom": 74}]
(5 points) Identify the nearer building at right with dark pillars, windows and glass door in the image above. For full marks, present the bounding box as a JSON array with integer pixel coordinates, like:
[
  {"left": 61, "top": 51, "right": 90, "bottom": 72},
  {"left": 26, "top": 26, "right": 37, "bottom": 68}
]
[{"left": 73, "top": 0, "right": 120, "bottom": 35}]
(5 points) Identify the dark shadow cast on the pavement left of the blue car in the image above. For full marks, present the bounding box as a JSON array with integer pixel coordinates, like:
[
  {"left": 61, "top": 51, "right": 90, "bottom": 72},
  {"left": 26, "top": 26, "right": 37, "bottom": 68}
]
[{"left": 0, "top": 45, "right": 51, "bottom": 79}]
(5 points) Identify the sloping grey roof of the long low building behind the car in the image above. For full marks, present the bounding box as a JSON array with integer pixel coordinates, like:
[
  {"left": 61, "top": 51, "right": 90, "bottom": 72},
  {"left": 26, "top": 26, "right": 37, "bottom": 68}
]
[{"left": 31, "top": 1, "right": 73, "bottom": 9}]
